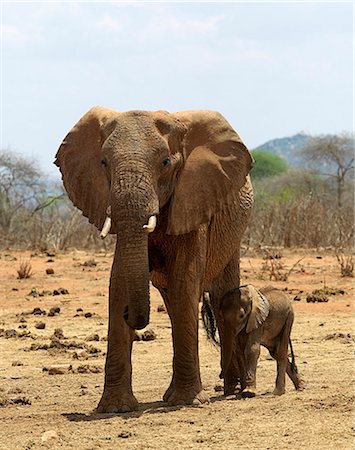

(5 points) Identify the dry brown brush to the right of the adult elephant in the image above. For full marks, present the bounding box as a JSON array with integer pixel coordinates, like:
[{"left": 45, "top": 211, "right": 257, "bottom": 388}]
[{"left": 245, "top": 172, "right": 354, "bottom": 249}]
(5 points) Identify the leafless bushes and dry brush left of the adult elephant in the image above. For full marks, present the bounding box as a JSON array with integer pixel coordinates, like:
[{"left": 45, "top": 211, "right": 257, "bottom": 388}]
[{"left": 0, "top": 150, "right": 114, "bottom": 251}]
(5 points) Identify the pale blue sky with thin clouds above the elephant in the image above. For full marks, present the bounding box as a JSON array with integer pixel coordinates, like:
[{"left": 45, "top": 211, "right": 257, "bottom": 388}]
[{"left": 0, "top": 0, "right": 354, "bottom": 179}]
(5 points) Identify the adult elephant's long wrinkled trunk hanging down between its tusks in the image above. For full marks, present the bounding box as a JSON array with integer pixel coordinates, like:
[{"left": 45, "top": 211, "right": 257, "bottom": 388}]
[{"left": 111, "top": 173, "right": 159, "bottom": 330}]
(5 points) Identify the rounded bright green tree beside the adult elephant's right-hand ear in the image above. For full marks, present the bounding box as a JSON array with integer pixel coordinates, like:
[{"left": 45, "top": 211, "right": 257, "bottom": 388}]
[{"left": 251, "top": 150, "right": 289, "bottom": 180}]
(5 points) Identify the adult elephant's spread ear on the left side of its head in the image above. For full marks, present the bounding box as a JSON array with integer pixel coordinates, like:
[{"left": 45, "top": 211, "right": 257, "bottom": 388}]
[{"left": 54, "top": 106, "right": 119, "bottom": 232}]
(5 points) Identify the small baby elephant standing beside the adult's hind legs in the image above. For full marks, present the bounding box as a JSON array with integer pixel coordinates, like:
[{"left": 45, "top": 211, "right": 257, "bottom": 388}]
[{"left": 221, "top": 285, "right": 303, "bottom": 397}]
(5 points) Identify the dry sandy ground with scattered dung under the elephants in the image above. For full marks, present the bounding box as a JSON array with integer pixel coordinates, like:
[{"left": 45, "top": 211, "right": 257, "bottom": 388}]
[{"left": 0, "top": 251, "right": 355, "bottom": 450}]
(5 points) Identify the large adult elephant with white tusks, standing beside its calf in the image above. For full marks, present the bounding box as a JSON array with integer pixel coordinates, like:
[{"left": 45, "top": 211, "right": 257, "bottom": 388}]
[{"left": 55, "top": 107, "right": 252, "bottom": 412}]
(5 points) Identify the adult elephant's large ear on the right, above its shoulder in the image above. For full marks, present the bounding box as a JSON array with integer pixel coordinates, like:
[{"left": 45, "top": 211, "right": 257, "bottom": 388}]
[{"left": 167, "top": 111, "right": 253, "bottom": 235}]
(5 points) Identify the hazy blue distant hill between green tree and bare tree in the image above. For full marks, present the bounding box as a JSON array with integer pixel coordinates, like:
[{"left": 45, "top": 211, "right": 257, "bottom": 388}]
[{"left": 253, "top": 133, "right": 310, "bottom": 166}]
